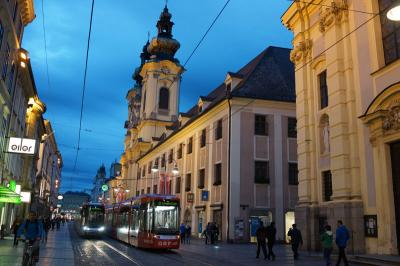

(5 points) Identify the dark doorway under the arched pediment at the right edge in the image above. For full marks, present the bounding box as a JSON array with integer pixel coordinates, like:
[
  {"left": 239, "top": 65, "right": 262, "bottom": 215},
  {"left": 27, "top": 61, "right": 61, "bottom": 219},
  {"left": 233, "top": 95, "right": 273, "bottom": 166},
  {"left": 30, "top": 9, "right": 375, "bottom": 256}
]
[{"left": 390, "top": 142, "right": 400, "bottom": 254}]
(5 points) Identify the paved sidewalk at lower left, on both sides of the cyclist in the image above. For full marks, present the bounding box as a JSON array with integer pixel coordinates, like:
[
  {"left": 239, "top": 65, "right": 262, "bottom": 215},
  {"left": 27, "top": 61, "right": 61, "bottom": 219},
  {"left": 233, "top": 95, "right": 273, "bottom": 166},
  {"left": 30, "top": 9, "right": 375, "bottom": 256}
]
[{"left": 0, "top": 224, "right": 74, "bottom": 266}]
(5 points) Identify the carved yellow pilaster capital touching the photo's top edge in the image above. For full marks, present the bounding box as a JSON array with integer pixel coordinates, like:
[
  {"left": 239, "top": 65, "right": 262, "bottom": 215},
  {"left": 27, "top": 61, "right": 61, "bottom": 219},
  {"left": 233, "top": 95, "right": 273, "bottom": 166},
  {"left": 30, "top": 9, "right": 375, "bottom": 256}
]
[{"left": 319, "top": 0, "right": 348, "bottom": 32}]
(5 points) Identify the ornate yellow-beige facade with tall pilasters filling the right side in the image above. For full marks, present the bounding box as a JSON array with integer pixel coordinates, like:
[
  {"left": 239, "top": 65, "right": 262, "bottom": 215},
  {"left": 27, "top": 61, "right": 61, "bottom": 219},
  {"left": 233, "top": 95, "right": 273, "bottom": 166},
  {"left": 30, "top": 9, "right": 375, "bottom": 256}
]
[{"left": 282, "top": 0, "right": 400, "bottom": 254}]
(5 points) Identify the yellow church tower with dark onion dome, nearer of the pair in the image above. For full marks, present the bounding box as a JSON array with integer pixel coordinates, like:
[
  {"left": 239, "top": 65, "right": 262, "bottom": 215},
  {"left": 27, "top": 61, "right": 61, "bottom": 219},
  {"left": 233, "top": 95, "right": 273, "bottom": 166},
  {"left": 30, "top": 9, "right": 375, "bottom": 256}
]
[{"left": 138, "top": 6, "right": 184, "bottom": 142}]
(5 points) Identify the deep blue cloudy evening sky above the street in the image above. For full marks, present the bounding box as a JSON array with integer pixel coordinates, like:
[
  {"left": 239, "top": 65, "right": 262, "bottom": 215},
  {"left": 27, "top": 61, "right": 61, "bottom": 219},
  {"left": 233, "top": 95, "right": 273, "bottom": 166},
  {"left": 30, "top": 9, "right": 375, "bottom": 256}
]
[{"left": 22, "top": 0, "right": 292, "bottom": 191}]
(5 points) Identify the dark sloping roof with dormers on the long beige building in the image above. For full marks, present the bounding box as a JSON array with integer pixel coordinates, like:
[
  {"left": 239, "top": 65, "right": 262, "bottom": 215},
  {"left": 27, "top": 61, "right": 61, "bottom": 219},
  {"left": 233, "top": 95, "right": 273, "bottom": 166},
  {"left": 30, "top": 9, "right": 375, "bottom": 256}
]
[{"left": 139, "top": 46, "right": 296, "bottom": 160}]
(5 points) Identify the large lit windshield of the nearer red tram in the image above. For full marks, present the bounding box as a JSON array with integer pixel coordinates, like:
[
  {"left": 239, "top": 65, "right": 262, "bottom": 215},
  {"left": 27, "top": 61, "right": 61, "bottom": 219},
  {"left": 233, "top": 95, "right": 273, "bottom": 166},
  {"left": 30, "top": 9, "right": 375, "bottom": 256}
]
[{"left": 154, "top": 202, "right": 179, "bottom": 233}]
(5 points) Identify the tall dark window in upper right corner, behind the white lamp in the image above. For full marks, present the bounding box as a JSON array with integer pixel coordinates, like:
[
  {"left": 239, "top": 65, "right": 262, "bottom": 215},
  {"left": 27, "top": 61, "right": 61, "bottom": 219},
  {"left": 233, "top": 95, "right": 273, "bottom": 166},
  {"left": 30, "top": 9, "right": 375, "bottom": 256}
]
[{"left": 379, "top": 0, "right": 400, "bottom": 64}]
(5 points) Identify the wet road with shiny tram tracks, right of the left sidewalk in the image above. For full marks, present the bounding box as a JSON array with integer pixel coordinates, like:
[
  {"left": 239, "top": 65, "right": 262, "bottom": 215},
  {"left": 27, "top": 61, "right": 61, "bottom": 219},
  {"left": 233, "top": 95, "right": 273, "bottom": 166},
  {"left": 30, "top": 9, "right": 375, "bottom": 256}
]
[{"left": 70, "top": 226, "right": 330, "bottom": 266}]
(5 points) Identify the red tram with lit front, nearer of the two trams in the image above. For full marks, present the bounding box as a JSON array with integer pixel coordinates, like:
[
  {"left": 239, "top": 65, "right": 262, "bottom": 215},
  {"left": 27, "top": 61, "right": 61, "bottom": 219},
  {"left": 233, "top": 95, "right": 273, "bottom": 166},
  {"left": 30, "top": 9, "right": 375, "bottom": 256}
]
[{"left": 106, "top": 194, "right": 180, "bottom": 249}]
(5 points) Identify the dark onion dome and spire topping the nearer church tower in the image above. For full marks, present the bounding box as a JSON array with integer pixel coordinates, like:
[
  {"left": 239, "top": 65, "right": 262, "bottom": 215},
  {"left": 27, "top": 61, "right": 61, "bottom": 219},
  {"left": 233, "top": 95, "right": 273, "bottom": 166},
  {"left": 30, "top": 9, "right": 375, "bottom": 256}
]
[{"left": 147, "top": 6, "right": 180, "bottom": 60}]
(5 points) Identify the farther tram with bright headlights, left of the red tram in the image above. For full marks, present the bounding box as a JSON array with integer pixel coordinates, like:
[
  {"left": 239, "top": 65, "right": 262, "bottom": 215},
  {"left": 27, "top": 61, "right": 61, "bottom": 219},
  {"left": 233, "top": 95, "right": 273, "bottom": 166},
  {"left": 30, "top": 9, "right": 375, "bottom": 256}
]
[{"left": 76, "top": 203, "right": 106, "bottom": 236}]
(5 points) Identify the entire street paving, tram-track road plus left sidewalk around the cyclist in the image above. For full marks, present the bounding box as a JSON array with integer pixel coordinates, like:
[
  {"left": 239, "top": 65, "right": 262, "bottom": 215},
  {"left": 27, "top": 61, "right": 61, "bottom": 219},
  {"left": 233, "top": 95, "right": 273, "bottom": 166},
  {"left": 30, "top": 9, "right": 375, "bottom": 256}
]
[{"left": 0, "top": 224, "right": 362, "bottom": 266}]
